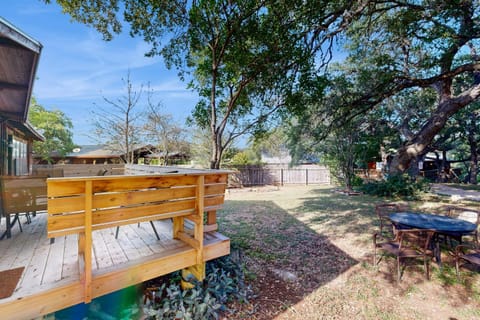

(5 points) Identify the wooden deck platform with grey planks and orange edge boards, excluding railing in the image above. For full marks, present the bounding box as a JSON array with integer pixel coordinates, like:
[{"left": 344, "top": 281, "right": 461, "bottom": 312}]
[{"left": 0, "top": 214, "right": 230, "bottom": 319}]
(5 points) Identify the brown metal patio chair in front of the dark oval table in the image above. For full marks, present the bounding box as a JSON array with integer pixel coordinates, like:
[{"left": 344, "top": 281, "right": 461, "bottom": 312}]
[{"left": 373, "top": 229, "right": 435, "bottom": 281}]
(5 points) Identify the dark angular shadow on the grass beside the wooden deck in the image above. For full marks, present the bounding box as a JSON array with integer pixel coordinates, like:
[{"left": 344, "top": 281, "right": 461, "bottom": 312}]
[{"left": 218, "top": 196, "right": 358, "bottom": 319}]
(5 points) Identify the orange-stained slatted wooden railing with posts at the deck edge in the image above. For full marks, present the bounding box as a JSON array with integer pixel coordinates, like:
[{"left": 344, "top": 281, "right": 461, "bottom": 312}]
[{"left": 47, "top": 172, "right": 227, "bottom": 303}]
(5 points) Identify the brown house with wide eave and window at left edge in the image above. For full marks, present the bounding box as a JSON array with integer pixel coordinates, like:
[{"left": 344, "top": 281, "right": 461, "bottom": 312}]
[{"left": 0, "top": 17, "right": 44, "bottom": 175}]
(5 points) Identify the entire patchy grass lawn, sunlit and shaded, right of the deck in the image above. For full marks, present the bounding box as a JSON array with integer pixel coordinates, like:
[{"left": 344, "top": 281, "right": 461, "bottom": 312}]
[{"left": 218, "top": 186, "right": 480, "bottom": 320}]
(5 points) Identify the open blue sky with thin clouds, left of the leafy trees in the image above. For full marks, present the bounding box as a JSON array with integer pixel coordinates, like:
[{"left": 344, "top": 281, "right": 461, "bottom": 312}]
[{"left": 0, "top": 0, "right": 197, "bottom": 144}]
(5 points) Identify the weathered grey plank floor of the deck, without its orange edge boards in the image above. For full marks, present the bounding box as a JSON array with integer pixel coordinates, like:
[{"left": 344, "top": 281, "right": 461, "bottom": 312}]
[{"left": 0, "top": 214, "right": 178, "bottom": 298}]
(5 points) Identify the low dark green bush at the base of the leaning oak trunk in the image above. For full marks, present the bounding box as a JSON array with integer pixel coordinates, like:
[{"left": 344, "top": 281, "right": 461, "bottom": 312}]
[{"left": 360, "top": 174, "right": 430, "bottom": 199}]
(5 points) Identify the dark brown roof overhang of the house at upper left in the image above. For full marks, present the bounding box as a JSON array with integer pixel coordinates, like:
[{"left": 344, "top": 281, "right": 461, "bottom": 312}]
[{"left": 0, "top": 17, "right": 42, "bottom": 123}]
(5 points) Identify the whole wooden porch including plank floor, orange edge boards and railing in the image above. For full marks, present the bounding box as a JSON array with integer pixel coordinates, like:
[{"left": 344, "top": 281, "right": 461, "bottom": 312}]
[{"left": 0, "top": 171, "right": 230, "bottom": 319}]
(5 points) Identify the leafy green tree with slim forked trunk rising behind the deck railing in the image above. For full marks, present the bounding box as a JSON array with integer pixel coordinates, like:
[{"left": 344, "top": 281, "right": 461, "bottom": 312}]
[{"left": 46, "top": 0, "right": 366, "bottom": 168}]
